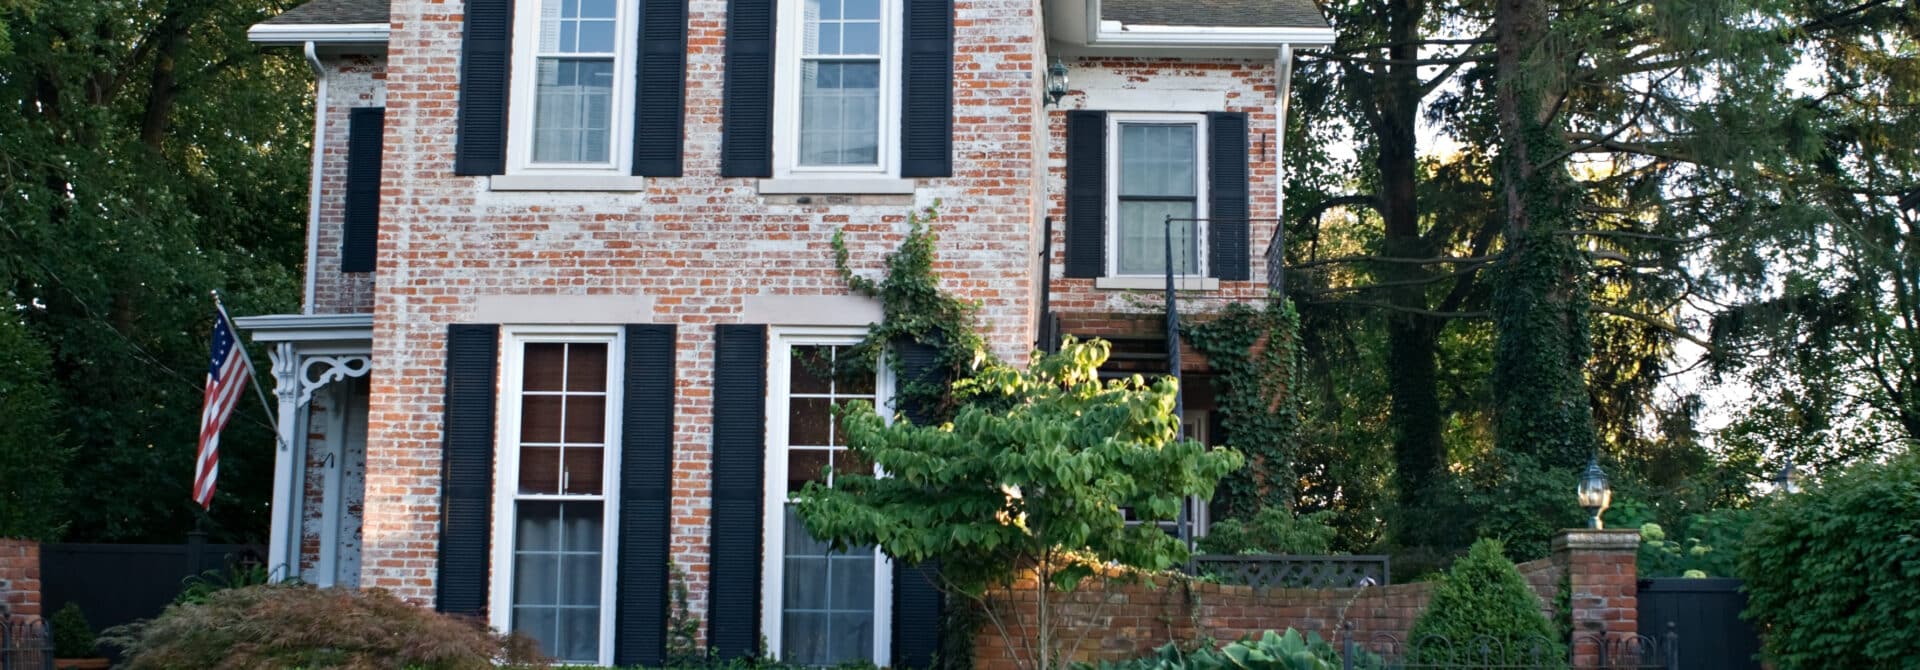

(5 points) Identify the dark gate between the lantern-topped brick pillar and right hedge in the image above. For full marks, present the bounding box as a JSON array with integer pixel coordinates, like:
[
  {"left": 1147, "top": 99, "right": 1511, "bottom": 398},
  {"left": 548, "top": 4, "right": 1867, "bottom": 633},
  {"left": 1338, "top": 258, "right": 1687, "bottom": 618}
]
[{"left": 1640, "top": 580, "right": 1761, "bottom": 670}]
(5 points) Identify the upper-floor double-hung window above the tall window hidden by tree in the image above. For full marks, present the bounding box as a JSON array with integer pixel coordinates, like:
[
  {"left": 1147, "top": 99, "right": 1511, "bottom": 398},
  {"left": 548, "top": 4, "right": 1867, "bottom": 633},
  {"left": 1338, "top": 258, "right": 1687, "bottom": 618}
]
[{"left": 774, "top": 0, "right": 900, "bottom": 177}]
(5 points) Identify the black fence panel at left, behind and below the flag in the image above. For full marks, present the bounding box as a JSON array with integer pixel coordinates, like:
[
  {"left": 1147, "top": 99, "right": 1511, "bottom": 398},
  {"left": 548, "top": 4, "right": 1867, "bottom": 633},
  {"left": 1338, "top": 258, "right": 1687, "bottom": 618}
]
[{"left": 40, "top": 541, "right": 257, "bottom": 632}]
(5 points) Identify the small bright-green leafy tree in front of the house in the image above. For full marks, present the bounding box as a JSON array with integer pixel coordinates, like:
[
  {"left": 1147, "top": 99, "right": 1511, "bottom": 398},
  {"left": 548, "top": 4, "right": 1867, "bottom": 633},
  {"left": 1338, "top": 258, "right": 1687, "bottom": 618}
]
[{"left": 799, "top": 340, "right": 1242, "bottom": 670}]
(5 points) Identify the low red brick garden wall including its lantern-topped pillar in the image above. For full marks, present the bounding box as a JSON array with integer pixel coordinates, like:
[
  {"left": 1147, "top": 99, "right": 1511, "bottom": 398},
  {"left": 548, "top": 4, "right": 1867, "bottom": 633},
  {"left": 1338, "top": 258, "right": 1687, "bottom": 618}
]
[{"left": 975, "top": 532, "right": 1638, "bottom": 670}]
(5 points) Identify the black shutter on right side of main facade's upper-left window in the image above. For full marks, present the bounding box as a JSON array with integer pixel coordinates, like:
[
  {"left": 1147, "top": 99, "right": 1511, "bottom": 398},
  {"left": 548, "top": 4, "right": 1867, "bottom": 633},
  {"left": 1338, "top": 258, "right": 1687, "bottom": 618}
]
[{"left": 634, "top": 0, "right": 687, "bottom": 177}]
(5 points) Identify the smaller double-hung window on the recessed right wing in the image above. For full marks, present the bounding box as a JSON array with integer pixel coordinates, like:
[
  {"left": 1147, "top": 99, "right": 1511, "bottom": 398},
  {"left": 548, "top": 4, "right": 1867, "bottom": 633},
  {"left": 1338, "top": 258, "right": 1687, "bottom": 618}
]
[{"left": 1106, "top": 113, "right": 1208, "bottom": 276}]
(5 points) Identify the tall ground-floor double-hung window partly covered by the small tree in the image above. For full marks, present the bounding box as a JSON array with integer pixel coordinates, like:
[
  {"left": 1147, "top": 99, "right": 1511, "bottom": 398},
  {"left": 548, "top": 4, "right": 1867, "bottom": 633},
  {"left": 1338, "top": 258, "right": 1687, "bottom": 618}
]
[{"left": 760, "top": 330, "right": 893, "bottom": 666}]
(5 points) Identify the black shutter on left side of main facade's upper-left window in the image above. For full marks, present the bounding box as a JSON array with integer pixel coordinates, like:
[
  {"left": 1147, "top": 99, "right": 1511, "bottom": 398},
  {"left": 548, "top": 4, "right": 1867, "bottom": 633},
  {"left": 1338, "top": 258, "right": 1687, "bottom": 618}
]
[{"left": 453, "top": 0, "right": 513, "bottom": 175}]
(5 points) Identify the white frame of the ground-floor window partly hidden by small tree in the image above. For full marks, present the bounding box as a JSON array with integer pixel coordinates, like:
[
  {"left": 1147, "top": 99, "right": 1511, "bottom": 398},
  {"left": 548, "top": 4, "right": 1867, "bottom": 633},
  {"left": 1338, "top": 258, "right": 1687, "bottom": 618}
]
[{"left": 760, "top": 326, "right": 893, "bottom": 668}]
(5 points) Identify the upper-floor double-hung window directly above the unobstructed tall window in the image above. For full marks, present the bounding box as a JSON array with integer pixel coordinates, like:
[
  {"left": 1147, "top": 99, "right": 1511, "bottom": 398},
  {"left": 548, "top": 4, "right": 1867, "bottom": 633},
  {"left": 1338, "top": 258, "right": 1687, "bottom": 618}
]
[{"left": 507, "top": 0, "right": 637, "bottom": 175}]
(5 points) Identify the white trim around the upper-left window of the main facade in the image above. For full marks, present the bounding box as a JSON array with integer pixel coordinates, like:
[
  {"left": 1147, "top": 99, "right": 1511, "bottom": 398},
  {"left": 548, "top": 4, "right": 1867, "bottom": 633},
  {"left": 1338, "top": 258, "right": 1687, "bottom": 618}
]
[{"left": 497, "top": 0, "right": 639, "bottom": 174}]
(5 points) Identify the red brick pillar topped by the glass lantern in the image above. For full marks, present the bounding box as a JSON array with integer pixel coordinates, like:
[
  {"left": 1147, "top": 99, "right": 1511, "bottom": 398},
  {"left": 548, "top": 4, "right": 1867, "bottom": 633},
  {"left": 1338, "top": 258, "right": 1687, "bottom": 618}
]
[{"left": 1553, "top": 528, "right": 1640, "bottom": 666}]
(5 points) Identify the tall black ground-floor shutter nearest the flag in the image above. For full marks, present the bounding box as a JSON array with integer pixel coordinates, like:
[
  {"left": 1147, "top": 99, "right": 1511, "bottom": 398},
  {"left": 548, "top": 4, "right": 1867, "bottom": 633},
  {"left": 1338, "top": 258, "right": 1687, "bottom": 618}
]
[{"left": 434, "top": 324, "right": 499, "bottom": 616}]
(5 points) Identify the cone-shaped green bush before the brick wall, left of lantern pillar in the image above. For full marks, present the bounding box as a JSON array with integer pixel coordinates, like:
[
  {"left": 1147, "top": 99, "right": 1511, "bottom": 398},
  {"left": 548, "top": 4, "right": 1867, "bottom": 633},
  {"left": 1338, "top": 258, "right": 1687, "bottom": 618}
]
[{"left": 1407, "top": 539, "right": 1567, "bottom": 668}]
